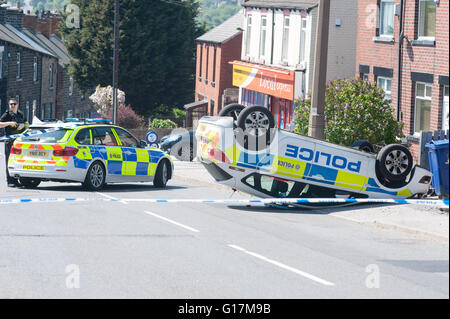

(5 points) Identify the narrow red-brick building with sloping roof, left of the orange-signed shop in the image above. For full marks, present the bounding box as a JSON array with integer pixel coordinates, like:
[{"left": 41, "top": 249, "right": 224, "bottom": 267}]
[{"left": 185, "top": 12, "right": 243, "bottom": 127}]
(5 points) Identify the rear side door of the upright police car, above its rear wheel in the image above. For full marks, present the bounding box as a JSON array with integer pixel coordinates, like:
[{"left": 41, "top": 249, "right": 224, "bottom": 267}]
[{"left": 91, "top": 126, "right": 125, "bottom": 182}]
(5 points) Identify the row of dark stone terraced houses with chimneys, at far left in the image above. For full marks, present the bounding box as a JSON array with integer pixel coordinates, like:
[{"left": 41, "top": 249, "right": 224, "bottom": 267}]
[{"left": 0, "top": 6, "right": 97, "bottom": 126}]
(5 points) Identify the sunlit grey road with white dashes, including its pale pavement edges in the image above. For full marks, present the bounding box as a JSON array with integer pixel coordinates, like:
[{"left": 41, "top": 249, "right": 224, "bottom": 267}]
[{"left": 0, "top": 149, "right": 449, "bottom": 298}]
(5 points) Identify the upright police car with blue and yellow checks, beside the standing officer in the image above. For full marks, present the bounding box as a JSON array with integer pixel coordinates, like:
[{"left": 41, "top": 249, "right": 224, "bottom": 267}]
[{"left": 8, "top": 120, "right": 173, "bottom": 191}]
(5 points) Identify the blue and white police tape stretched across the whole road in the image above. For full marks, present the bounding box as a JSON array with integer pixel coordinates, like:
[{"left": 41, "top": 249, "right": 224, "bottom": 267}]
[{"left": 0, "top": 198, "right": 449, "bottom": 208}]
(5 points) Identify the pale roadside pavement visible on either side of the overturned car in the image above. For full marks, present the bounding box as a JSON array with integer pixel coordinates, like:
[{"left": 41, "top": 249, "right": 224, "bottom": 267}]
[{"left": 174, "top": 159, "right": 449, "bottom": 244}]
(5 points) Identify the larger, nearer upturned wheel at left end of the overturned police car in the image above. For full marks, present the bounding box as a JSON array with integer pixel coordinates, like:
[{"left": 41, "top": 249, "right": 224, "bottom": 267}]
[{"left": 236, "top": 106, "right": 275, "bottom": 151}]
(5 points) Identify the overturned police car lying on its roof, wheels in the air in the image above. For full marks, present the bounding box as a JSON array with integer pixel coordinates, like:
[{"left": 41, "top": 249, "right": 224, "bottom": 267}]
[{"left": 196, "top": 104, "right": 432, "bottom": 199}]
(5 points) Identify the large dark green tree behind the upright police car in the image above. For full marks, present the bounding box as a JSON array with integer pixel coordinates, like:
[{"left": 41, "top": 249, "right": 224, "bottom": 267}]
[{"left": 61, "top": 0, "right": 203, "bottom": 116}]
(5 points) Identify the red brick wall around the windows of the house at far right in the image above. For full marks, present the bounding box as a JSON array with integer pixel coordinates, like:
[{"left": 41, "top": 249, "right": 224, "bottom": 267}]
[{"left": 356, "top": 0, "right": 449, "bottom": 160}]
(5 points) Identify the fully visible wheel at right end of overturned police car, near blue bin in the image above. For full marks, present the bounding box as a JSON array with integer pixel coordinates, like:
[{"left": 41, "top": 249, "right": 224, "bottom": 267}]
[{"left": 377, "top": 144, "right": 413, "bottom": 182}]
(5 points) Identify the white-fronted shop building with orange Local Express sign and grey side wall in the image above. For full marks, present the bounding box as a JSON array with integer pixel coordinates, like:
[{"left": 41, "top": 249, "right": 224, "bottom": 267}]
[{"left": 232, "top": 0, "right": 357, "bottom": 129}]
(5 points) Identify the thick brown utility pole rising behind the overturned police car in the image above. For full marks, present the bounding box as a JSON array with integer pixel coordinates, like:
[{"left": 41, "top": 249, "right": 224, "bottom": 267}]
[{"left": 308, "top": 0, "right": 330, "bottom": 140}]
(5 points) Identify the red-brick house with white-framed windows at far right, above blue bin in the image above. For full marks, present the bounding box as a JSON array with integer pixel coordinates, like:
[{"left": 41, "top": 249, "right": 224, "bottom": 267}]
[{"left": 356, "top": 0, "right": 449, "bottom": 160}]
